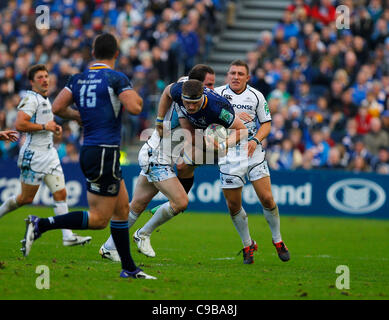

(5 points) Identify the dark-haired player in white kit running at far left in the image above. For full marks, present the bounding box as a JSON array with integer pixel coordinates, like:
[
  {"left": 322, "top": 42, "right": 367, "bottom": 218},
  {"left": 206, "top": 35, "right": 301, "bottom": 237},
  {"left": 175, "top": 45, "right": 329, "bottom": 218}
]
[{"left": 0, "top": 64, "right": 92, "bottom": 246}]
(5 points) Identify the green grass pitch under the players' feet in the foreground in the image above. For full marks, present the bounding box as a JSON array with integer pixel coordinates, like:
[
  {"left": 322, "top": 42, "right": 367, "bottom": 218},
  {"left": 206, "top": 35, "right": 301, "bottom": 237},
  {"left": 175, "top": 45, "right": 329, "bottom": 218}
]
[{"left": 0, "top": 207, "right": 389, "bottom": 300}]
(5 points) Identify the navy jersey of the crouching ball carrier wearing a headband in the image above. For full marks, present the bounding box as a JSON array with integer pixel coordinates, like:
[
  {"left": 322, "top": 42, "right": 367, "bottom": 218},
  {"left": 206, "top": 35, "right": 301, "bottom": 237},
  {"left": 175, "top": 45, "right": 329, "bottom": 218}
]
[{"left": 170, "top": 82, "right": 235, "bottom": 129}]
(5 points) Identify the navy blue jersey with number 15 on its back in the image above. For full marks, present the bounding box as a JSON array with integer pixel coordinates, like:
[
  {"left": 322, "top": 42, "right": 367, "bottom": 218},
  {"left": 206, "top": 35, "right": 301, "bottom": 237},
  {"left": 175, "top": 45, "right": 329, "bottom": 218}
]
[{"left": 66, "top": 63, "right": 132, "bottom": 146}]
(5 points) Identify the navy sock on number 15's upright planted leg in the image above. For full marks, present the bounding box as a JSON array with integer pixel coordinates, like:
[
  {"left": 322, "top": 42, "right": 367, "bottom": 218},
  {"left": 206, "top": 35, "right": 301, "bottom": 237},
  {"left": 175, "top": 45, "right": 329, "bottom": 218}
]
[{"left": 111, "top": 220, "right": 136, "bottom": 272}]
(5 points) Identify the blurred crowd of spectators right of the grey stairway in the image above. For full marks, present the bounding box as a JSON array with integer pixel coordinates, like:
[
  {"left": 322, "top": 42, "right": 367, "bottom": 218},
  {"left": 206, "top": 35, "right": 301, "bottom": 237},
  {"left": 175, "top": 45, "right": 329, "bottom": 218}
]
[{"left": 247, "top": 0, "right": 389, "bottom": 174}]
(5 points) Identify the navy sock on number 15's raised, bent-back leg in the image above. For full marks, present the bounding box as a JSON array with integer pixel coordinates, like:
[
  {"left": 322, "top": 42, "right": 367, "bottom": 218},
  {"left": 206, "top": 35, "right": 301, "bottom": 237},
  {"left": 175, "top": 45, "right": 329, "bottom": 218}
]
[{"left": 38, "top": 211, "right": 88, "bottom": 233}]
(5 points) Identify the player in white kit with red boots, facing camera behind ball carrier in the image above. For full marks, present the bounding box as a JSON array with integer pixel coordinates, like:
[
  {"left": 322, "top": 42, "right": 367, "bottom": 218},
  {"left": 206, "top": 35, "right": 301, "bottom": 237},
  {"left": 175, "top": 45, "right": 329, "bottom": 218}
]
[{"left": 215, "top": 60, "right": 290, "bottom": 264}]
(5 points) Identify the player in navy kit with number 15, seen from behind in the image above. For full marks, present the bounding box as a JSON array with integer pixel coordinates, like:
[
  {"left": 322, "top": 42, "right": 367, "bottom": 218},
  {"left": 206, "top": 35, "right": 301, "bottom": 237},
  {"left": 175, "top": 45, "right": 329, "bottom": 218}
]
[{"left": 22, "top": 34, "right": 156, "bottom": 279}]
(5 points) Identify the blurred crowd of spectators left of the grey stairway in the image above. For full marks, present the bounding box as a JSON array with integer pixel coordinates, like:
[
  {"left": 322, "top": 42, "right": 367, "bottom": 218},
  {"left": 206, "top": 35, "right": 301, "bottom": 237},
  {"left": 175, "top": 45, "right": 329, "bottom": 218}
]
[{"left": 0, "top": 0, "right": 226, "bottom": 161}]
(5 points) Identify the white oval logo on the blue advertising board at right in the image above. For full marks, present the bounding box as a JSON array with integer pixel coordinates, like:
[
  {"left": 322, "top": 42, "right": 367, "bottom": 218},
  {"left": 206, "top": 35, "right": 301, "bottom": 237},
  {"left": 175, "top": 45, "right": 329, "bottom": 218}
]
[{"left": 327, "top": 179, "right": 386, "bottom": 214}]
